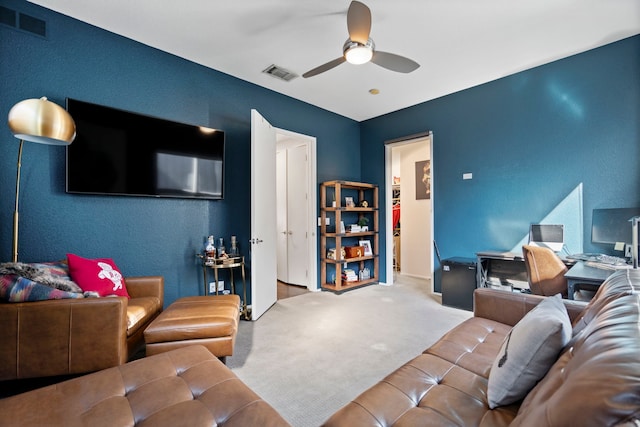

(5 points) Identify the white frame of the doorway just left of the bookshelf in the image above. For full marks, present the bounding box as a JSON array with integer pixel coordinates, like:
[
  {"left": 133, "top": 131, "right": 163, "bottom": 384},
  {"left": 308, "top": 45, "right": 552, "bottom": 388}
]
[{"left": 274, "top": 127, "right": 320, "bottom": 292}]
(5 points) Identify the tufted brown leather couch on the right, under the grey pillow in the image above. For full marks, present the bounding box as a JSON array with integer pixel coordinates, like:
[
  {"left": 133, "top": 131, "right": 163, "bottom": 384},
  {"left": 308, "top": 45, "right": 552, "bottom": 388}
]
[{"left": 324, "top": 270, "right": 640, "bottom": 427}]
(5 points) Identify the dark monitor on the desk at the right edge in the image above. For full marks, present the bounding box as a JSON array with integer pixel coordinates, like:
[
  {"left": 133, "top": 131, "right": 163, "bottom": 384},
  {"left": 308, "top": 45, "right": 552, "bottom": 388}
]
[{"left": 591, "top": 208, "right": 640, "bottom": 245}]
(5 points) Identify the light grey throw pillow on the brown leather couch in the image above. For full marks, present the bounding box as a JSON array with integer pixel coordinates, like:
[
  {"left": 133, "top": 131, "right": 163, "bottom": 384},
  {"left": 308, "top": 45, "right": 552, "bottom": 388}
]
[{"left": 487, "top": 294, "right": 571, "bottom": 409}]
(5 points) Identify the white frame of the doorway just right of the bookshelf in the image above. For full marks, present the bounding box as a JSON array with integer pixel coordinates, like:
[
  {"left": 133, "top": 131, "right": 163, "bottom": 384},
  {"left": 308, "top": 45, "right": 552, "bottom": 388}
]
[{"left": 384, "top": 131, "right": 436, "bottom": 292}]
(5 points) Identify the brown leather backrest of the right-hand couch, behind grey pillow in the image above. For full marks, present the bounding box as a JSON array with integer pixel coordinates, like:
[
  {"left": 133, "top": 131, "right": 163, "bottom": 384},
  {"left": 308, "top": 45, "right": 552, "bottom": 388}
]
[{"left": 512, "top": 270, "right": 640, "bottom": 427}]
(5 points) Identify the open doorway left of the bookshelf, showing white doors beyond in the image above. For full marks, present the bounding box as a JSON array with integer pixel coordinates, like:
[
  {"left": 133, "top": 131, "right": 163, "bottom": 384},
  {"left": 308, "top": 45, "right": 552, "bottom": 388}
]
[{"left": 276, "top": 129, "right": 317, "bottom": 299}]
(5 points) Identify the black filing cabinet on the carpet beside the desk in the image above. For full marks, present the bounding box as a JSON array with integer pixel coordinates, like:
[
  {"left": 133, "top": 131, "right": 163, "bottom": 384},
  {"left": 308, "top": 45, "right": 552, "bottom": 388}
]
[{"left": 442, "top": 257, "right": 477, "bottom": 311}]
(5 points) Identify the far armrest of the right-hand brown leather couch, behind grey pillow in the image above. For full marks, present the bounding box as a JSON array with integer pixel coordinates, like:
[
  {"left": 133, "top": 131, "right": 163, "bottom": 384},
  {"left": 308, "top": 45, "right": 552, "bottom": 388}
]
[{"left": 473, "top": 288, "right": 587, "bottom": 326}]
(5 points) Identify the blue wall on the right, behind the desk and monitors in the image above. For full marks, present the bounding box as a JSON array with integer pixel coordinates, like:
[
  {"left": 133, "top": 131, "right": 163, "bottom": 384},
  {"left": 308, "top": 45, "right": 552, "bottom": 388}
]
[{"left": 361, "top": 36, "right": 640, "bottom": 290}]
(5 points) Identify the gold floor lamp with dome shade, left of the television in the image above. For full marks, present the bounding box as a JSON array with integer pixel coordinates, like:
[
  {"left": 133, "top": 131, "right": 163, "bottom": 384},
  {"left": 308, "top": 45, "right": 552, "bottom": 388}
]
[{"left": 9, "top": 97, "right": 76, "bottom": 262}]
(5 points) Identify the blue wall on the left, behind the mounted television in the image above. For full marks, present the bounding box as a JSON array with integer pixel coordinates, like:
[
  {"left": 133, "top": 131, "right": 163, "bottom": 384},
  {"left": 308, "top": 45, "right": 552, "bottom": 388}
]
[{"left": 0, "top": 0, "right": 360, "bottom": 304}]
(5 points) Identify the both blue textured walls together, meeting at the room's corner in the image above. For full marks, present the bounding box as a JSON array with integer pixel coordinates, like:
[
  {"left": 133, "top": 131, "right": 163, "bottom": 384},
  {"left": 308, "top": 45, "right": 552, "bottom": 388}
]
[{"left": 0, "top": 0, "right": 640, "bottom": 304}]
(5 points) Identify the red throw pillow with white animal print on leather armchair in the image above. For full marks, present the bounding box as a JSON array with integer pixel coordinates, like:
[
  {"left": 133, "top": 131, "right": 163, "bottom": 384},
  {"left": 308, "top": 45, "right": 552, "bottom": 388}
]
[{"left": 67, "top": 254, "right": 129, "bottom": 298}]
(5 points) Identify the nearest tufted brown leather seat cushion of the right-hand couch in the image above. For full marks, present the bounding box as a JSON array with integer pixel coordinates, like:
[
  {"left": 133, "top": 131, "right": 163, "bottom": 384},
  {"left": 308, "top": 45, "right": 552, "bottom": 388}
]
[{"left": 323, "top": 354, "right": 518, "bottom": 427}]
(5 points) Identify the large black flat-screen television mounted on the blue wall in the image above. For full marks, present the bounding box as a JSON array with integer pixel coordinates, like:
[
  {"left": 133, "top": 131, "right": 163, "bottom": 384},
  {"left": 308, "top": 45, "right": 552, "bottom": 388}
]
[{"left": 66, "top": 98, "right": 225, "bottom": 200}]
